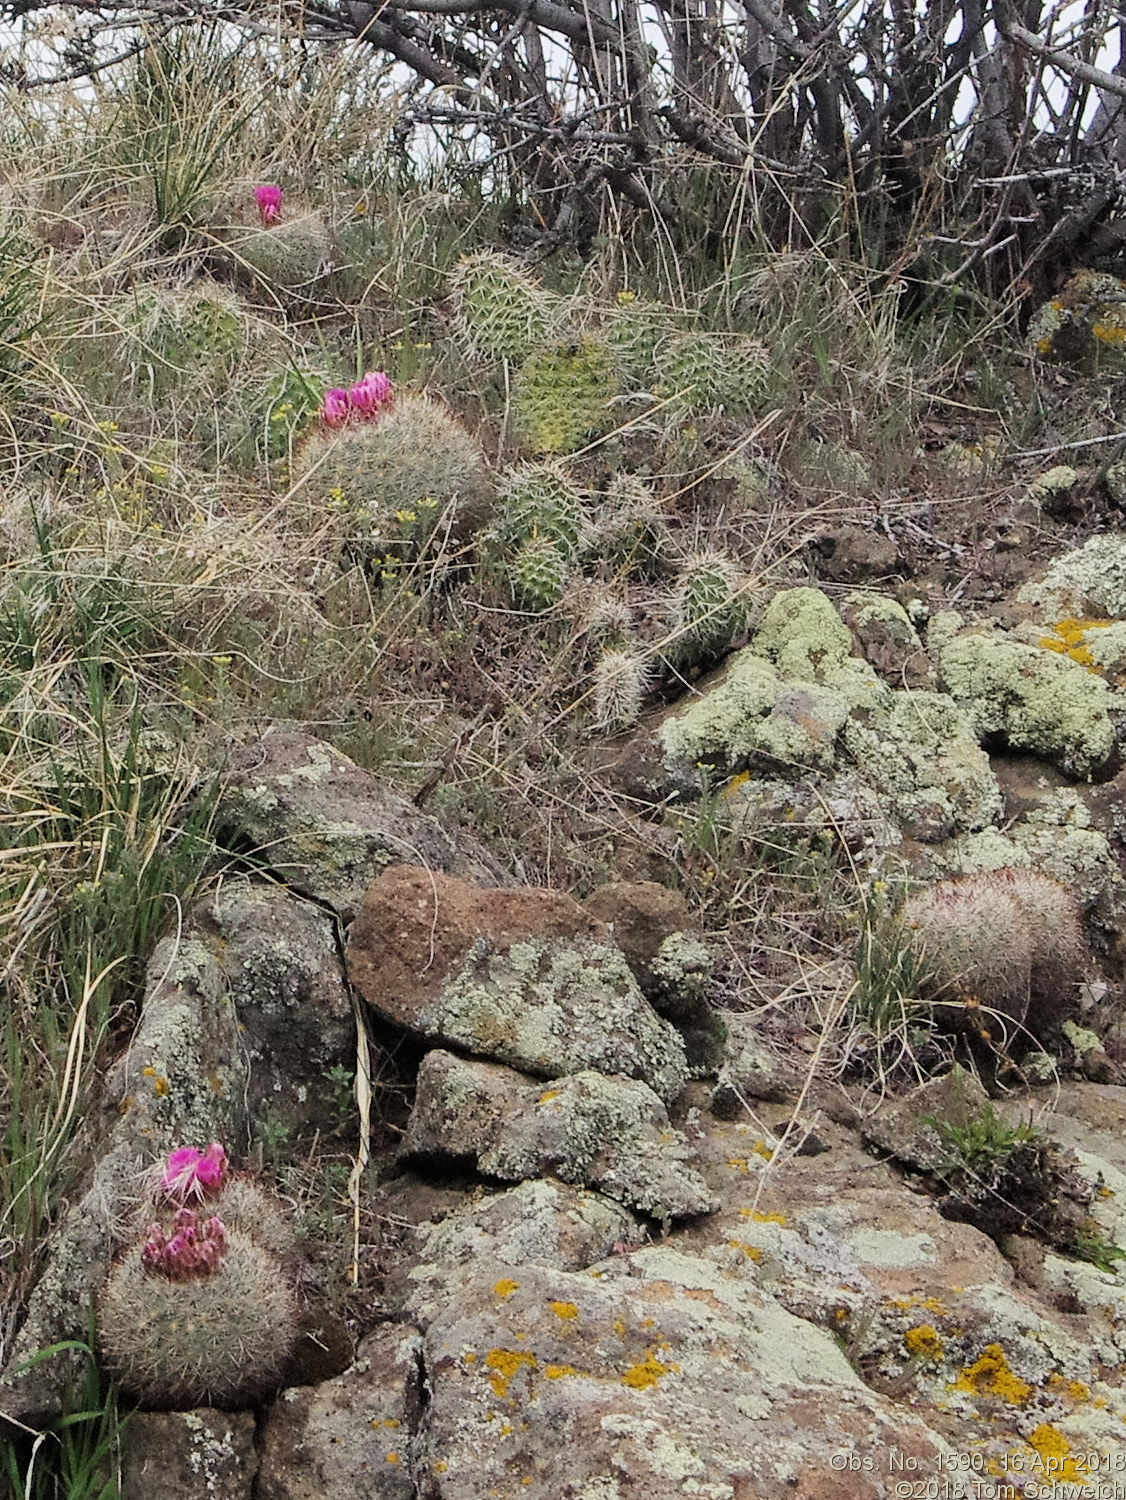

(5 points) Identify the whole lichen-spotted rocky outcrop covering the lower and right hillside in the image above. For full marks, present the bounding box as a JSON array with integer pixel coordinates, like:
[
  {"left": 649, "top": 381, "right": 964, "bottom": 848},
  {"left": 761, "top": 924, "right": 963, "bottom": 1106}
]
[{"left": 15, "top": 276, "right": 1126, "bottom": 1500}]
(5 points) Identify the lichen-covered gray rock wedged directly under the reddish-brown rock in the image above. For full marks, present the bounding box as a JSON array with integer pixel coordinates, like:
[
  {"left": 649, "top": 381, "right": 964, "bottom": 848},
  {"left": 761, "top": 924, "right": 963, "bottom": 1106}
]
[{"left": 403, "top": 1052, "right": 711, "bottom": 1221}]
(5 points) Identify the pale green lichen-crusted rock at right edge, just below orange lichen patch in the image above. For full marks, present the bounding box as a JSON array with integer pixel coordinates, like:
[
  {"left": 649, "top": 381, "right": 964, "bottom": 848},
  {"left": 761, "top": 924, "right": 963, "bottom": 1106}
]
[{"left": 939, "top": 632, "right": 1117, "bottom": 777}]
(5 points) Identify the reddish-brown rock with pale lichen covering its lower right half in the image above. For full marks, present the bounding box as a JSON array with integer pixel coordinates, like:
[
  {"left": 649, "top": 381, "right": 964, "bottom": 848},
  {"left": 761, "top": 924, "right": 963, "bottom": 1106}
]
[{"left": 348, "top": 866, "right": 688, "bottom": 1100}]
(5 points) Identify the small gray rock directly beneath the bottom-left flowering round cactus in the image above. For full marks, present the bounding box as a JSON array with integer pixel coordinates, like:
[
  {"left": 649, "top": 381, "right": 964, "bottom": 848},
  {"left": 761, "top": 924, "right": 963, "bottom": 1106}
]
[{"left": 121, "top": 1407, "right": 258, "bottom": 1500}]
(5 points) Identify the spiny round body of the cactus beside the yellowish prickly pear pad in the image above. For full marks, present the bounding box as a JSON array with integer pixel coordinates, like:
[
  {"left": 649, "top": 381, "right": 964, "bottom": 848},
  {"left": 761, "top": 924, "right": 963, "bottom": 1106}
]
[{"left": 295, "top": 396, "right": 490, "bottom": 555}]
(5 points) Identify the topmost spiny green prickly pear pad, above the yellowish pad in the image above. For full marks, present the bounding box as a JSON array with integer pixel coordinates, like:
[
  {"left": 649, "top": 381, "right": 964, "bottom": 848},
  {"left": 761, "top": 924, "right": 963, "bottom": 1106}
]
[{"left": 451, "top": 251, "right": 565, "bottom": 365}]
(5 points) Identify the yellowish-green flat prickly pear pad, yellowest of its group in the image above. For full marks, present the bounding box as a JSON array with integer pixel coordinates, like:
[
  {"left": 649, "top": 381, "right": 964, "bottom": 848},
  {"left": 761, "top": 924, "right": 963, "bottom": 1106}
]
[{"left": 514, "top": 336, "right": 616, "bottom": 453}]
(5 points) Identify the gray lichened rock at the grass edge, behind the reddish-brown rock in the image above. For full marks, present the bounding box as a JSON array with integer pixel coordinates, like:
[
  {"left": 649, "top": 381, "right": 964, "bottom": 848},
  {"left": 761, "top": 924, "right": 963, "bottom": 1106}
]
[{"left": 220, "top": 731, "right": 505, "bottom": 921}]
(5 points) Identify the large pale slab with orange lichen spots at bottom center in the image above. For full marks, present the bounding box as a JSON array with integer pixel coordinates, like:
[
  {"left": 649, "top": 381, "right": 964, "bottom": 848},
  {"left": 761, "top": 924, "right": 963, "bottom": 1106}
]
[{"left": 415, "top": 1250, "right": 940, "bottom": 1500}]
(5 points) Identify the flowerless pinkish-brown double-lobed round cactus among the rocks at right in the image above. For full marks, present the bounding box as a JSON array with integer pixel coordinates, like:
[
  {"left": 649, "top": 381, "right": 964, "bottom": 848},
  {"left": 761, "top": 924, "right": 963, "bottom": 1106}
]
[{"left": 903, "top": 869, "right": 1084, "bottom": 1035}]
